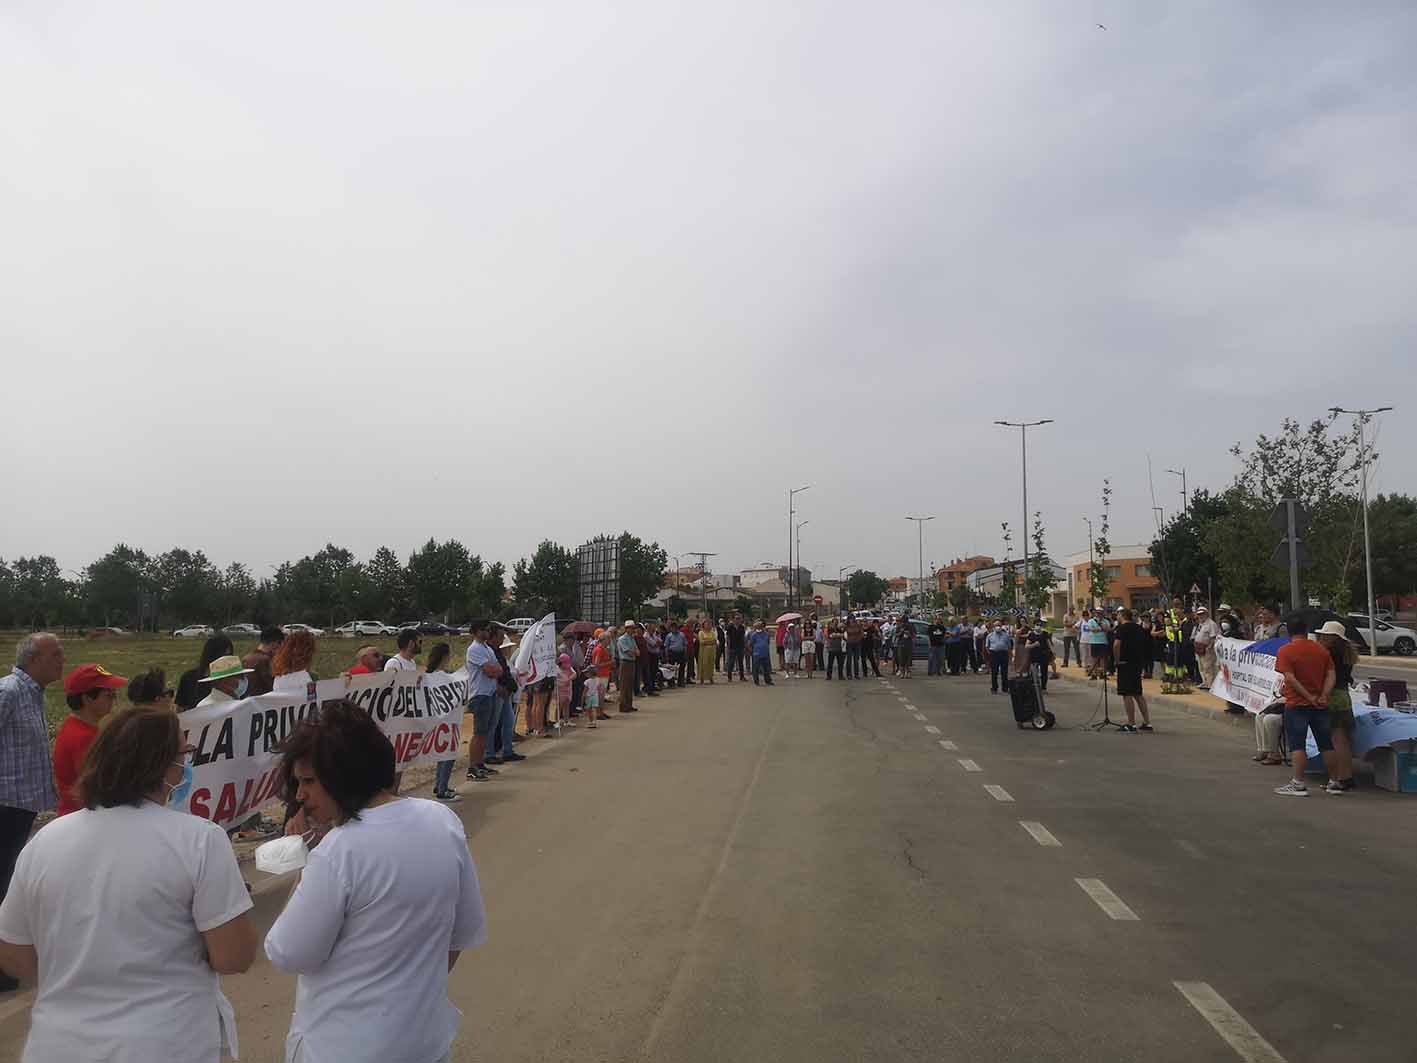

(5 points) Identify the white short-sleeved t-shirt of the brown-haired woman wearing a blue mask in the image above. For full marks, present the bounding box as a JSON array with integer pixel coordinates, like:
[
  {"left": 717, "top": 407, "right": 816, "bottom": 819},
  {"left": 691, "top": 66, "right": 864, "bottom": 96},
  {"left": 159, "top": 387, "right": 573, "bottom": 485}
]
[{"left": 0, "top": 801, "right": 251, "bottom": 1063}]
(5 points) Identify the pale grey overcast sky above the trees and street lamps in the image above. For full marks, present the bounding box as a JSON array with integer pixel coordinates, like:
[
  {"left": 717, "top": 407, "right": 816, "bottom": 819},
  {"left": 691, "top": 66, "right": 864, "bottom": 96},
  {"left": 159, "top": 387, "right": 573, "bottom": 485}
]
[{"left": 0, "top": 0, "right": 1417, "bottom": 575}]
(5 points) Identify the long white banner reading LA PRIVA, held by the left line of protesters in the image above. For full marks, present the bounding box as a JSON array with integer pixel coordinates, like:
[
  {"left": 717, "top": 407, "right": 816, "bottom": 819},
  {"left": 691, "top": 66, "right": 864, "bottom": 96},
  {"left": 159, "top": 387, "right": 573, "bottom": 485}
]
[{"left": 177, "top": 670, "right": 468, "bottom": 828}]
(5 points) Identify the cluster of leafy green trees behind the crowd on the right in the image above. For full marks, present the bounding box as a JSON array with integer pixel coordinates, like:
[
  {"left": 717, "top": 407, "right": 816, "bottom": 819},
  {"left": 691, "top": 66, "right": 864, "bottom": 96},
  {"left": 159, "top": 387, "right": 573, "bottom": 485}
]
[{"left": 1151, "top": 420, "right": 1417, "bottom": 611}]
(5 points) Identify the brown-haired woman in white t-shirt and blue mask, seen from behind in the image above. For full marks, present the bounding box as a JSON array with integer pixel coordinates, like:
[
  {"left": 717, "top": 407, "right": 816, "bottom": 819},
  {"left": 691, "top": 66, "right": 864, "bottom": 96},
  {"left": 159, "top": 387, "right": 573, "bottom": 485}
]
[{"left": 0, "top": 706, "right": 256, "bottom": 1063}]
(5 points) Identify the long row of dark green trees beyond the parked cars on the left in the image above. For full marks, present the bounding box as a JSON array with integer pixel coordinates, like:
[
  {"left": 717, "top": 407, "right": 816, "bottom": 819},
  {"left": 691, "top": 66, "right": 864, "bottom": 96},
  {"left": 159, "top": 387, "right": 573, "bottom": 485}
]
[{"left": 0, "top": 532, "right": 667, "bottom": 631}]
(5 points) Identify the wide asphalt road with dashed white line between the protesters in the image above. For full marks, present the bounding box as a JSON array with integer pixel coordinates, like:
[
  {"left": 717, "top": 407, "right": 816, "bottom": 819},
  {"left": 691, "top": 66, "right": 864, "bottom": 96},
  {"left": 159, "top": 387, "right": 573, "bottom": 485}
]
[{"left": 0, "top": 676, "right": 1417, "bottom": 1063}]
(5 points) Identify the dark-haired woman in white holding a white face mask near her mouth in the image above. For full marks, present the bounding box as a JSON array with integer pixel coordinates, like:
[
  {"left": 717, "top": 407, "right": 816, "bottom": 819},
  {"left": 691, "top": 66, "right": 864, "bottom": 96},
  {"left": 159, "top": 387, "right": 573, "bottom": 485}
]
[{"left": 265, "top": 702, "right": 487, "bottom": 1063}]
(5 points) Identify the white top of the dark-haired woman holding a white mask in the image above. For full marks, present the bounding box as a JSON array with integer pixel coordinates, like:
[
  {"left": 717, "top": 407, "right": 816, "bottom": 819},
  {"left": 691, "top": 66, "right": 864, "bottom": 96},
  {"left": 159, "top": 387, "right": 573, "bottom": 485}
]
[{"left": 265, "top": 798, "right": 487, "bottom": 1063}]
